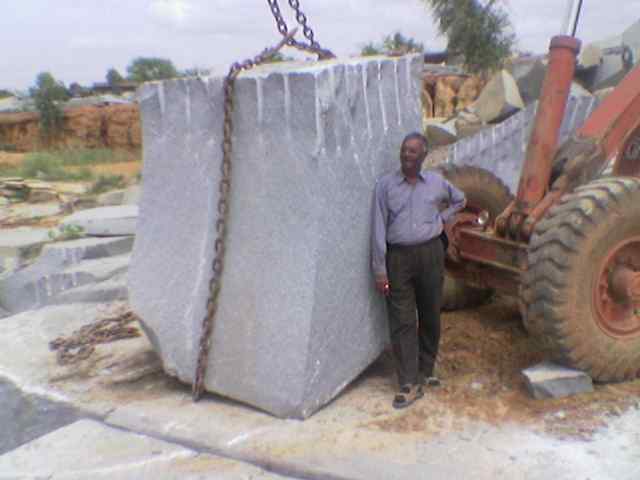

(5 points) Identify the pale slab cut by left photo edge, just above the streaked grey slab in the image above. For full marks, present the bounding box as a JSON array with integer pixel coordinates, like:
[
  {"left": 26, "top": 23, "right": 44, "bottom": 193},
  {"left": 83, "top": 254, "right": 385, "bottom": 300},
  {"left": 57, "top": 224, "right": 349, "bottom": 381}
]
[{"left": 0, "top": 227, "right": 51, "bottom": 274}]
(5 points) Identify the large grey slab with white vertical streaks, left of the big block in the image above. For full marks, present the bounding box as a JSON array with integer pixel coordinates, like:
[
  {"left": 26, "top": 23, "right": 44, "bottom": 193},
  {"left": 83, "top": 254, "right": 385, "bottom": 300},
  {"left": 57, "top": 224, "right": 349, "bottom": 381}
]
[{"left": 0, "top": 237, "right": 133, "bottom": 313}]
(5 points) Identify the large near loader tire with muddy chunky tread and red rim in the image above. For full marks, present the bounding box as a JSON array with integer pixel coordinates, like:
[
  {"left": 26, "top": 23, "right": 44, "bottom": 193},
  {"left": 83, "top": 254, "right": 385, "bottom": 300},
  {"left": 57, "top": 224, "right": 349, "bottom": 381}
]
[{"left": 521, "top": 177, "right": 640, "bottom": 381}]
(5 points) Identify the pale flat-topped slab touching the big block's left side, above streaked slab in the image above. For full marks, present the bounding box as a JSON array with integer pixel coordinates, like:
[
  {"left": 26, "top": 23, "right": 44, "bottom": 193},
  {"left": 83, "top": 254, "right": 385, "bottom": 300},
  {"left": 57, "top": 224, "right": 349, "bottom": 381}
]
[{"left": 61, "top": 205, "right": 138, "bottom": 237}]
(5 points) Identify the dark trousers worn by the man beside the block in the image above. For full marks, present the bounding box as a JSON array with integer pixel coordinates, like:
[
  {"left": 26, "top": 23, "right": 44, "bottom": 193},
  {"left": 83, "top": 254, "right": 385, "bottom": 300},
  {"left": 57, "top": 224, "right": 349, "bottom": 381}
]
[{"left": 386, "top": 237, "right": 444, "bottom": 386}]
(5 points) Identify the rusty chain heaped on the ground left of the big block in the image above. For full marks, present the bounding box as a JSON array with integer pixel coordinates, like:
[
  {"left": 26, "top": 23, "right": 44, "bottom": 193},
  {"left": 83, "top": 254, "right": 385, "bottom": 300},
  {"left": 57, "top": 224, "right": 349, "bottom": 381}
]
[{"left": 49, "top": 312, "right": 140, "bottom": 365}]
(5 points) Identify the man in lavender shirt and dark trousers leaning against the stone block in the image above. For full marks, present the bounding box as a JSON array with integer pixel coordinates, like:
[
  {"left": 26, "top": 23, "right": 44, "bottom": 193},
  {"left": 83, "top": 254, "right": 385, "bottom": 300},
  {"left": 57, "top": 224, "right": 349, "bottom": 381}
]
[{"left": 371, "top": 133, "right": 465, "bottom": 408}]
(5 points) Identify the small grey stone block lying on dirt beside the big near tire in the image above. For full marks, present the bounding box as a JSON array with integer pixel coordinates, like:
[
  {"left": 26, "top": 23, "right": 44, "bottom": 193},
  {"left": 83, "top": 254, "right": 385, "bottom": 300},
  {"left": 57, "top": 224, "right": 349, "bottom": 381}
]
[{"left": 522, "top": 362, "right": 593, "bottom": 399}]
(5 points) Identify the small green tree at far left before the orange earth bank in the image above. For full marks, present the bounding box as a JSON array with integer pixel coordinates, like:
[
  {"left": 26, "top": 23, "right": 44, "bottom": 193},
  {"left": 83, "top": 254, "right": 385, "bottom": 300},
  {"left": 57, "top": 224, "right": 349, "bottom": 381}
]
[{"left": 29, "top": 72, "right": 69, "bottom": 143}]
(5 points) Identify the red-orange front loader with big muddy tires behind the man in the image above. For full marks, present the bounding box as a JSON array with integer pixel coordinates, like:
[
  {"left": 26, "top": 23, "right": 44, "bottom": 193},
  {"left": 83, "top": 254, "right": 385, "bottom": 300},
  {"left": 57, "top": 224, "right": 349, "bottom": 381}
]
[{"left": 443, "top": 2, "right": 640, "bottom": 381}]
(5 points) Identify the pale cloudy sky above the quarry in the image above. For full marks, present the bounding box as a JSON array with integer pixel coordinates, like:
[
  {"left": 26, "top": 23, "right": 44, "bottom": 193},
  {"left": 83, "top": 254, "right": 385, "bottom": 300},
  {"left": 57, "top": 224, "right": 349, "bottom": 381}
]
[{"left": 0, "top": 0, "right": 640, "bottom": 90}]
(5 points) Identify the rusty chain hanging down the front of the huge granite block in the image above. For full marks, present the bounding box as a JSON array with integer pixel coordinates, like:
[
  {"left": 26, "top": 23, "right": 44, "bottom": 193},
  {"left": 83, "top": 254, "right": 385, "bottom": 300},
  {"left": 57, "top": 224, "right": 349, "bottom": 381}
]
[{"left": 192, "top": 0, "right": 334, "bottom": 401}]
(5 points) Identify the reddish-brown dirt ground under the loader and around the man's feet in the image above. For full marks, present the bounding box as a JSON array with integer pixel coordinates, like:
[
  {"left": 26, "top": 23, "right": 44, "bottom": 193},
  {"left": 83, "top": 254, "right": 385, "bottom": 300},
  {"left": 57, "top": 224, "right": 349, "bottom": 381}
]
[{"left": 366, "top": 299, "right": 640, "bottom": 439}]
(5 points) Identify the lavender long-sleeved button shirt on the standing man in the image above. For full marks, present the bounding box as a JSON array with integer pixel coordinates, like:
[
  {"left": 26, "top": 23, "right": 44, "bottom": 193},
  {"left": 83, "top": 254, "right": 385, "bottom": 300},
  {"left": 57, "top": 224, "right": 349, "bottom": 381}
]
[{"left": 371, "top": 170, "right": 465, "bottom": 276}]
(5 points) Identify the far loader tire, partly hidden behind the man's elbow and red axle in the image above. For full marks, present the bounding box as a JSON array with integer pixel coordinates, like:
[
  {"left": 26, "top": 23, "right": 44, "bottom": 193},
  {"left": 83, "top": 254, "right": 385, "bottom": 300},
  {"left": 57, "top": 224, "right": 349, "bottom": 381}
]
[{"left": 435, "top": 165, "right": 513, "bottom": 311}]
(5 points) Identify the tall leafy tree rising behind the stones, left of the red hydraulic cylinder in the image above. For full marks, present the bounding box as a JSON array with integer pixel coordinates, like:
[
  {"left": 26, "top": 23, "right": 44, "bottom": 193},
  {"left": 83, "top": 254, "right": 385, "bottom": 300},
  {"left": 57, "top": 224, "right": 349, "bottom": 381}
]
[{"left": 423, "top": 0, "right": 515, "bottom": 75}]
